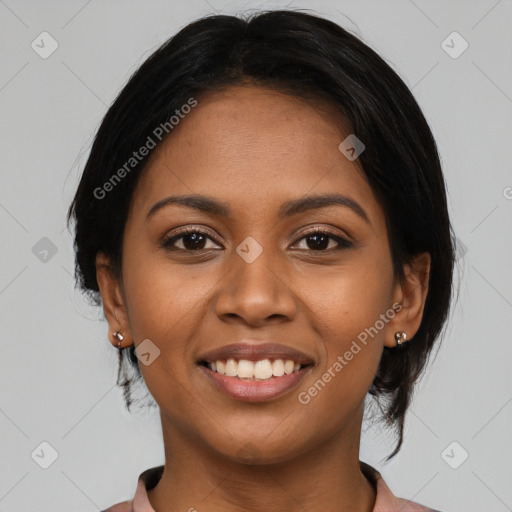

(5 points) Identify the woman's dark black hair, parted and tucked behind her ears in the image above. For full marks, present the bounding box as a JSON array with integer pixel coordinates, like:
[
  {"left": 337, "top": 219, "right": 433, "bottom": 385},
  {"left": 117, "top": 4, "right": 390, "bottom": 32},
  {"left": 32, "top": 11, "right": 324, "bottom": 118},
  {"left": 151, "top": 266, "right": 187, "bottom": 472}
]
[{"left": 67, "top": 10, "right": 455, "bottom": 459}]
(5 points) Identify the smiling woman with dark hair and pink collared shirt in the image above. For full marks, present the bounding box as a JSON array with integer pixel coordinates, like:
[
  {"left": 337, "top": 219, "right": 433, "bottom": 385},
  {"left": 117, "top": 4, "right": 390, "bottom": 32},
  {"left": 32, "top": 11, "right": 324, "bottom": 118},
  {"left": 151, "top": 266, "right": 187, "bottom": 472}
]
[{"left": 68, "top": 11, "right": 454, "bottom": 512}]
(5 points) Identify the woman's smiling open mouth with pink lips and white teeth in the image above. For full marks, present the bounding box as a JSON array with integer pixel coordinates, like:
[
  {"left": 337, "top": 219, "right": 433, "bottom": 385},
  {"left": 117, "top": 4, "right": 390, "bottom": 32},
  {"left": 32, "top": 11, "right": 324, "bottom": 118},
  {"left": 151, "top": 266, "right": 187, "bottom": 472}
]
[{"left": 197, "top": 343, "right": 315, "bottom": 402}]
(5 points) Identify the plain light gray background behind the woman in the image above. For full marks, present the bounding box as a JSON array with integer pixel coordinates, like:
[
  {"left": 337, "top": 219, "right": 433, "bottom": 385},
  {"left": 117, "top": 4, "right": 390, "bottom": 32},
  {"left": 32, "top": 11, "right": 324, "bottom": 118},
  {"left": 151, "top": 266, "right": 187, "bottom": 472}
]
[{"left": 0, "top": 0, "right": 512, "bottom": 512}]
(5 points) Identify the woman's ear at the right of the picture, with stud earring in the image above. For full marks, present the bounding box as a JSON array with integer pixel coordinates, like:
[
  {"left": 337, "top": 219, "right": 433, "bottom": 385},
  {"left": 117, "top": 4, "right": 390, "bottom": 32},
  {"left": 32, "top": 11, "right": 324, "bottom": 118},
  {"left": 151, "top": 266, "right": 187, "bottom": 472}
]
[{"left": 384, "top": 252, "right": 431, "bottom": 347}]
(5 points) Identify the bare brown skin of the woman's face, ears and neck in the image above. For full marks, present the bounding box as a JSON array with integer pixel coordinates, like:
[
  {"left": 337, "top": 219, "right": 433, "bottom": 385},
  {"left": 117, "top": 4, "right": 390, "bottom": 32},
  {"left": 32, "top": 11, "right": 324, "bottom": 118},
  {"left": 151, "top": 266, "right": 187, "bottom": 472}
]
[{"left": 96, "top": 85, "right": 430, "bottom": 512}]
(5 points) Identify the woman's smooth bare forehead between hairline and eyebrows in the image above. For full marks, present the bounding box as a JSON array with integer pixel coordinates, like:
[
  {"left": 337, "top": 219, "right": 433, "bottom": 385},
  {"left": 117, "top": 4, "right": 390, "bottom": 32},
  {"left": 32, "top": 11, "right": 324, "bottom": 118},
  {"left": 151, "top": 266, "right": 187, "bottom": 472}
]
[{"left": 131, "top": 86, "right": 379, "bottom": 230}]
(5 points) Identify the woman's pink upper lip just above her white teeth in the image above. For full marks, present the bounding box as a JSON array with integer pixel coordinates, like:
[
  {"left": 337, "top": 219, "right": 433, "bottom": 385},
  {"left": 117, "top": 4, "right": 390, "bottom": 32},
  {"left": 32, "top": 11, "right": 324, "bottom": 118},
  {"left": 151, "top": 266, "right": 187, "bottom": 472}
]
[{"left": 199, "top": 341, "right": 313, "bottom": 365}]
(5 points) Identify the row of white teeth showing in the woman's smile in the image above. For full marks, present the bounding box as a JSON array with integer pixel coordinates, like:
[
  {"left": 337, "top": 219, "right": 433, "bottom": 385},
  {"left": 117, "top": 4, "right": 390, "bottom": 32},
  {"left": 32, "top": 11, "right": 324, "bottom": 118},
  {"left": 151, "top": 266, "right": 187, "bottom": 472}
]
[{"left": 208, "top": 358, "right": 301, "bottom": 380}]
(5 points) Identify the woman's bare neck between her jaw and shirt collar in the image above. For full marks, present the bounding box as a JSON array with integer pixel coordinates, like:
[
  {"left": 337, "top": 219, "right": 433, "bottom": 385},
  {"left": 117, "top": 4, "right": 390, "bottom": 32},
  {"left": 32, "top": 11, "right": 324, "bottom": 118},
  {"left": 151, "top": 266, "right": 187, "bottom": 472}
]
[{"left": 148, "top": 410, "right": 376, "bottom": 512}]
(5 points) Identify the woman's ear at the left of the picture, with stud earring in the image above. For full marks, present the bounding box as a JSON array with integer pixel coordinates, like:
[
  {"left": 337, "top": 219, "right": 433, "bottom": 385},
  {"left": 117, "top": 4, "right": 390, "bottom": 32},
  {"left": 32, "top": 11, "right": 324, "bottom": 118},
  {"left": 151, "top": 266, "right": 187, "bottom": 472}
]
[{"left": 96, "top": 251, "right": 132, "bottom": 348}]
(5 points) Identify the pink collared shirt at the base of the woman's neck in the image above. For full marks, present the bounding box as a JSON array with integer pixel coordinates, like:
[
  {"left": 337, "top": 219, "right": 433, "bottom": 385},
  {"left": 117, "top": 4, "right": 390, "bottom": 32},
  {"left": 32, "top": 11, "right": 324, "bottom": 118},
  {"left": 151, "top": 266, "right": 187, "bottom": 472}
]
[{"left": 103, "top": 462, "right": 440, "bottom": 512}]
